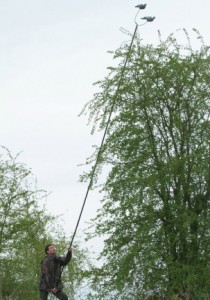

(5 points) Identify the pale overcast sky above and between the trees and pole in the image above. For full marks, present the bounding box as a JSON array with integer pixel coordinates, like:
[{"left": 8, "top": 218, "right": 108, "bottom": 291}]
[{"left": 0, "top": 0, "right": 210, "bottom": 248}]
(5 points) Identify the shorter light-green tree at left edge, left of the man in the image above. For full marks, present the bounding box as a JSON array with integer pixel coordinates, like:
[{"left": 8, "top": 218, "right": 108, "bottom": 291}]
[{"left": 0, "top": 149, "right": 58, "bottom": 300}]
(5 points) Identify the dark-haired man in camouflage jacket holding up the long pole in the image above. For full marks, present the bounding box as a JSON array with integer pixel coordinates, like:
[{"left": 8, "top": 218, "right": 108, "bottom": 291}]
[{"left": 39, "top": 244, "right": 72, "bottom": 300}]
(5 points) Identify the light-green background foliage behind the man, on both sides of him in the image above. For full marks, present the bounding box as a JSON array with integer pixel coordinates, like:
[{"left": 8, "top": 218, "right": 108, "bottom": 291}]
[{"left": 0, "top": 151, "right": 92, "bottom": 300}]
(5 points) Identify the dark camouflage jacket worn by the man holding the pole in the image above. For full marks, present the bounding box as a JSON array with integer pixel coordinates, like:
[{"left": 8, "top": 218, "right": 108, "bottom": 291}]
[{"left": 39, "top": 252, "right": 72, "bottom": 292}]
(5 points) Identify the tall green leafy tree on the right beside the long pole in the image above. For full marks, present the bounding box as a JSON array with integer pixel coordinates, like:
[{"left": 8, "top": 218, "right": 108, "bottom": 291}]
[{"left": 81, "top": 30, "right": 210, "bottom": 299}]
